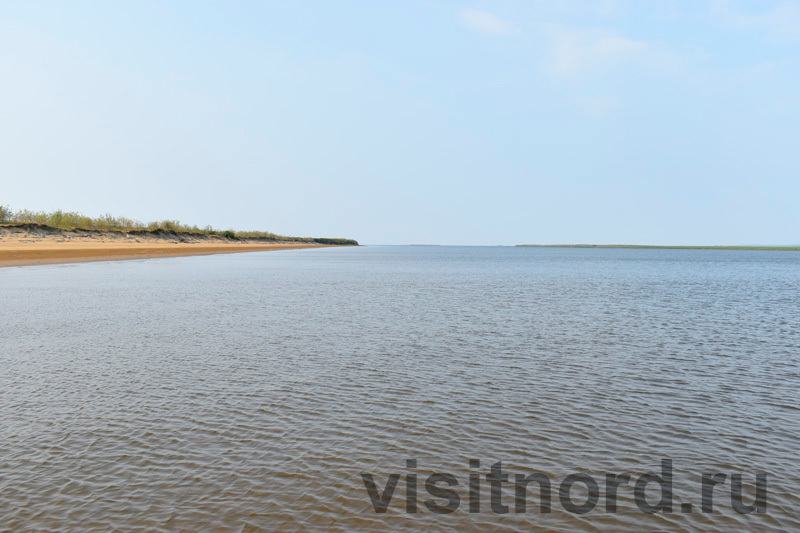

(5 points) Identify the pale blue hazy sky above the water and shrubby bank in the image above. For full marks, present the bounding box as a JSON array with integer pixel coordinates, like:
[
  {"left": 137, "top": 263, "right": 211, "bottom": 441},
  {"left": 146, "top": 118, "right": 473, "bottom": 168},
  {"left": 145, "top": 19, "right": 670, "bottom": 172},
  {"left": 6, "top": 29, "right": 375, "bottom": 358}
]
[{"left": 0, "top": 0, "right": 800, "bottom": 245}]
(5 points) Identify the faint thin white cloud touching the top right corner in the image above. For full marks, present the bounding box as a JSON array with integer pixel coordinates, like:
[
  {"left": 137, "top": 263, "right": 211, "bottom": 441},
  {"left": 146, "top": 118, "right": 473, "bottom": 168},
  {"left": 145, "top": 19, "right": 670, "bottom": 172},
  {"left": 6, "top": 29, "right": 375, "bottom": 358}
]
[{"left": 711, "top": 0, "right": 800, "bottom": 41}]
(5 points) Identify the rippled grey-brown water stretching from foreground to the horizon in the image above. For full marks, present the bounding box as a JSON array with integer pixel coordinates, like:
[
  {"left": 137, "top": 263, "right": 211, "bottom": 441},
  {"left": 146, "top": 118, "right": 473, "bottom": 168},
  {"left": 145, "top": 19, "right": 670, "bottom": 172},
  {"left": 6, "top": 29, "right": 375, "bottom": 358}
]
[{"left": 0, "top": 247, "right": 800, "bottom": 531}]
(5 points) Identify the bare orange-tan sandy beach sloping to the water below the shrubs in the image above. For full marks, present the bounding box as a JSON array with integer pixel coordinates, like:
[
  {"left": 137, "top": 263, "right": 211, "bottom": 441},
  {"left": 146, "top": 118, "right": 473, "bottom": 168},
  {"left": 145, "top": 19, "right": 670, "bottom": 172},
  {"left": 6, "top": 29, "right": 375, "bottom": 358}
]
[{"left": 0, "top": 224, "right": 350, "bottom": 267}]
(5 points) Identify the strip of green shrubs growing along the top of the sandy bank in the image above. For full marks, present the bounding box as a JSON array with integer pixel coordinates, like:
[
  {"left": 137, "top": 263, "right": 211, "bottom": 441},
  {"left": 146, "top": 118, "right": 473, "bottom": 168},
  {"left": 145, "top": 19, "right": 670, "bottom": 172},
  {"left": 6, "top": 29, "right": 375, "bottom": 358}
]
[{"left": 0, "top": 205, "right": 358, "bottom": 245}]
